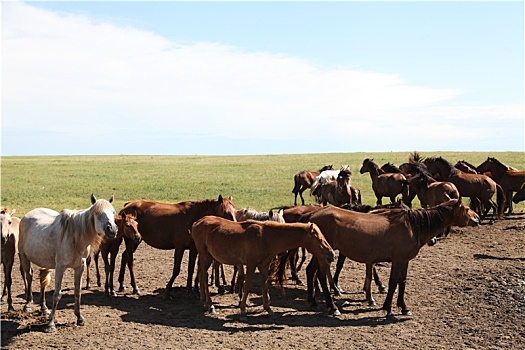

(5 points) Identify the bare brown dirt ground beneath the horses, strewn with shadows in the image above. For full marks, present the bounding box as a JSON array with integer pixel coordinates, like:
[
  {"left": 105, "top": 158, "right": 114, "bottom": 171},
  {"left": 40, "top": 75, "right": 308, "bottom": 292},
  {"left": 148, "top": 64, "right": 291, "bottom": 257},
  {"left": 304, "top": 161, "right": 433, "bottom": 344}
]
[{"left": 1, "top": 213, "right": 525, "bottom": 349}]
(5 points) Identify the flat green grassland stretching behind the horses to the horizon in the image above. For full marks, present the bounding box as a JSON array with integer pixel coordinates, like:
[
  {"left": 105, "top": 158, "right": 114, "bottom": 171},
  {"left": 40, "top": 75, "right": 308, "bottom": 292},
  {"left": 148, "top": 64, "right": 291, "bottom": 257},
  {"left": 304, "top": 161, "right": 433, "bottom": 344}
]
[{"left": 1, "top": 152, "right": 525, "bottom": 217}]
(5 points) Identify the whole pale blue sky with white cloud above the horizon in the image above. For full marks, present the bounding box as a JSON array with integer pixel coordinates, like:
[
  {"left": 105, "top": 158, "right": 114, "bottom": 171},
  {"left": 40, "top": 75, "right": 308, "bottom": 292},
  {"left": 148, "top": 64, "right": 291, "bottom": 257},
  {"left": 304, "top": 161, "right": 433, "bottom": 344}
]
[{"left": 1, "top": 1, "right": 525, "bottom": 155}]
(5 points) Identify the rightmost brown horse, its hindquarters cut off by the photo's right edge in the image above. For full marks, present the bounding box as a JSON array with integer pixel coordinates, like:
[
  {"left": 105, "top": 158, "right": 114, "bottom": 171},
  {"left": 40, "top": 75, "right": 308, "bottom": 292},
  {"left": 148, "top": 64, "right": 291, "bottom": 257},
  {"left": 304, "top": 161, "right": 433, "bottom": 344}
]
[{"left": 476, "top": 157, "right": 525, "bottom": 214}]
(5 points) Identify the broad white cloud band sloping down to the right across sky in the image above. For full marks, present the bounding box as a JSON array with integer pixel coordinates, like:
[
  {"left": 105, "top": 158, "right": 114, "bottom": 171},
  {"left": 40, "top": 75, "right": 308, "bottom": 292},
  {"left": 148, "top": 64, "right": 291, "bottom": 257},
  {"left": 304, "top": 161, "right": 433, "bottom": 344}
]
[{"left": 2, "top": 3, "right": 523, "bottom": 152}]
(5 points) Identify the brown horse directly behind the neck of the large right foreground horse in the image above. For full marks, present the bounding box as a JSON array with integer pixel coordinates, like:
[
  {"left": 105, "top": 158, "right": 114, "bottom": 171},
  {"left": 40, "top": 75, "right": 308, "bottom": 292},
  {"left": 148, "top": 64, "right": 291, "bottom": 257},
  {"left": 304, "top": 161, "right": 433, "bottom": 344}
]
[{"left": 403, "top": 163, "right": 459, "bottom": 208}]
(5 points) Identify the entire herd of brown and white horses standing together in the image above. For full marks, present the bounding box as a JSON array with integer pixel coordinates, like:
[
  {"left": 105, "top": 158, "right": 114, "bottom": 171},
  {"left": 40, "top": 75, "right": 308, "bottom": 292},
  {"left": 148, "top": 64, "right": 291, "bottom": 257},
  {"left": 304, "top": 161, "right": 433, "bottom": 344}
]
[{"left": 0, "top": 152, "right": 525, "bottom": 332}]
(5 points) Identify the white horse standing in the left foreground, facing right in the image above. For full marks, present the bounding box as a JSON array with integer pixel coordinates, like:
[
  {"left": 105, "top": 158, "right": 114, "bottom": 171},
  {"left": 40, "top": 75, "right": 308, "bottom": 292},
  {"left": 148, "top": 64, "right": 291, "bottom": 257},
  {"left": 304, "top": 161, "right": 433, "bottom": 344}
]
[{"left": 18, "top": 194, "right": 118, "bottom": 332}]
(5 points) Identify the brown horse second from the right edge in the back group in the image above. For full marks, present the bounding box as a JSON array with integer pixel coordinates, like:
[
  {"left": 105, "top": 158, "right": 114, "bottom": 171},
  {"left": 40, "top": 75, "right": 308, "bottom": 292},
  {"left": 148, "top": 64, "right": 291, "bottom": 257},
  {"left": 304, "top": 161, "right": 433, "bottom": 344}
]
[{"left": 423, "top": 157, "right": 505, "bottom": 220}]
